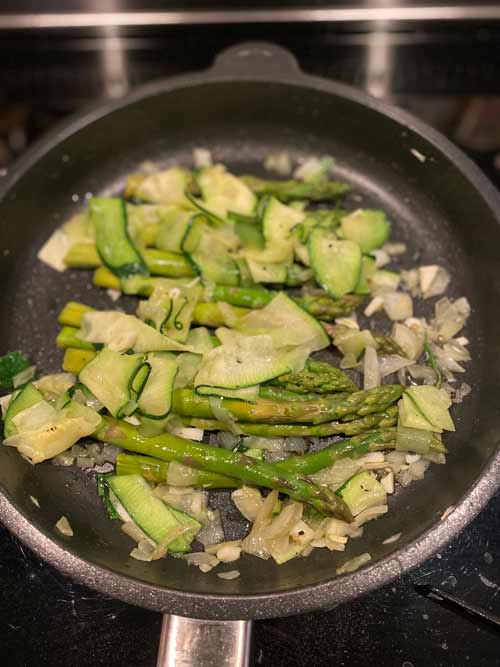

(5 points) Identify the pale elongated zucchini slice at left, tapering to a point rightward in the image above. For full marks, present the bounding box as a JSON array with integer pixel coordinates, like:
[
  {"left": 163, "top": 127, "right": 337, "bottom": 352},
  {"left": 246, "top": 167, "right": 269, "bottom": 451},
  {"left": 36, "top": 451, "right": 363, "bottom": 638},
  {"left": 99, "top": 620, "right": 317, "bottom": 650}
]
[{"left": 79, "top": 310, "right": 190, "bottom": 352}]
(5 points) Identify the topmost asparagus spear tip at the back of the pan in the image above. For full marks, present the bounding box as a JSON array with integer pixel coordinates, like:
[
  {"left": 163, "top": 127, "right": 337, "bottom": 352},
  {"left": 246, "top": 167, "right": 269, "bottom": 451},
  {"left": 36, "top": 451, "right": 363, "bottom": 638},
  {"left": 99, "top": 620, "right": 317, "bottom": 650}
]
[{"left": 241, "top": 176, "right": 350, "bottom": 202}]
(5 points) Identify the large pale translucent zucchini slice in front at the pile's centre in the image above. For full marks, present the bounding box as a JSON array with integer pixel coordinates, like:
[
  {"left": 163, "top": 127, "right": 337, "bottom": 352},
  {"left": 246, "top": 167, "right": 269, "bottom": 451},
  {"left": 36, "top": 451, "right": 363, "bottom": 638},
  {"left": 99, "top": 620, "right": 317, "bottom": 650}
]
[{"left": 194, "top": 335, "right": 310, "bottom": 389}]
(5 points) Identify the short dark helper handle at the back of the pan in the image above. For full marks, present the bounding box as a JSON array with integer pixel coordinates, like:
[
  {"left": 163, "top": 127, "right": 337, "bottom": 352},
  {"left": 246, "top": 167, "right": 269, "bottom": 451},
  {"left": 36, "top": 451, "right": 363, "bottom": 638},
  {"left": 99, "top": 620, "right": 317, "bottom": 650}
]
[{"left": 212, "top": 42, "right": 303, "bottom": 76}]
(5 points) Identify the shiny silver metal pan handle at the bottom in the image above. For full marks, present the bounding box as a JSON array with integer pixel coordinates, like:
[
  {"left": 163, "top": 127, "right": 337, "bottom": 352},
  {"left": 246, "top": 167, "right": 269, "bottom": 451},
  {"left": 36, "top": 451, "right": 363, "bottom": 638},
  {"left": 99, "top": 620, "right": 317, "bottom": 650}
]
[{"left": 156, "top": 614, "right": 252, "bottom": 667}]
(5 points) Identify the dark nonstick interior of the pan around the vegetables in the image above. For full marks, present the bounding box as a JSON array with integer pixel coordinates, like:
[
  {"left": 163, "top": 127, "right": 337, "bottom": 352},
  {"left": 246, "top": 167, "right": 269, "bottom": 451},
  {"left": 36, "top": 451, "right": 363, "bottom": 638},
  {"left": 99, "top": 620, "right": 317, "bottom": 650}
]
[{"left": 0, "top": 81, "right": 500, "bottom": 595}]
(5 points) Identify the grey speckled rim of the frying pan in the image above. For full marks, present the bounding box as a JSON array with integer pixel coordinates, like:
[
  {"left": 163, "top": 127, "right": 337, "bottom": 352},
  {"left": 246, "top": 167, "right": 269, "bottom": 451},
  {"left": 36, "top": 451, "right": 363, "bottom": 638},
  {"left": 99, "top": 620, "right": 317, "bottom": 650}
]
[{"left": 0, "top": 57, "right": 500, "bottom": 620}]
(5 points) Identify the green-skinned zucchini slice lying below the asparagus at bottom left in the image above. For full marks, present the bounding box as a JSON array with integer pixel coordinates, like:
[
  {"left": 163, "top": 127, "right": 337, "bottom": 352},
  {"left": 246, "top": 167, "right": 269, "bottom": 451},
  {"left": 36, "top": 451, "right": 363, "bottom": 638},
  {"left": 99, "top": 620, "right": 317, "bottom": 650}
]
[{"left": 106, "top": 475, "right": 201, "bottom": 552}]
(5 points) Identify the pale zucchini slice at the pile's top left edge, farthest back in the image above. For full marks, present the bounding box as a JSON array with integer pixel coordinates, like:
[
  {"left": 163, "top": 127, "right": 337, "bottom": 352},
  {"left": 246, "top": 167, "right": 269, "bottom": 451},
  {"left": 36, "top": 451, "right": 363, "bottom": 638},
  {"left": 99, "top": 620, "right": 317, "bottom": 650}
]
[{"left": 134, "top": 167, "right": 192, "bottom": 208}]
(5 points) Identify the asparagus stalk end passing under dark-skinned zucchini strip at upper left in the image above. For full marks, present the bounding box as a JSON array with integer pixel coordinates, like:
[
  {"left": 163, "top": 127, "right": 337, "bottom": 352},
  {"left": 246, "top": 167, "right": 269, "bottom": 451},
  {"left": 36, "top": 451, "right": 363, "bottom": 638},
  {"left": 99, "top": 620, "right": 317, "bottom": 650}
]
[{"left": 64, "top": 243, "right": 196, "bottom": 278}]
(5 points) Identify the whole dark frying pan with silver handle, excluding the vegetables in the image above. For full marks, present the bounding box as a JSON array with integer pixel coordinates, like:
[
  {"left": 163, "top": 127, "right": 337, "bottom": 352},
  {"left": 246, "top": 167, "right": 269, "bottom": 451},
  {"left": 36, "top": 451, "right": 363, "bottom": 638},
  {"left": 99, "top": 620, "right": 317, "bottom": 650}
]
[{"left": 0, "top": 44, "right": 500, "bottom": 664}]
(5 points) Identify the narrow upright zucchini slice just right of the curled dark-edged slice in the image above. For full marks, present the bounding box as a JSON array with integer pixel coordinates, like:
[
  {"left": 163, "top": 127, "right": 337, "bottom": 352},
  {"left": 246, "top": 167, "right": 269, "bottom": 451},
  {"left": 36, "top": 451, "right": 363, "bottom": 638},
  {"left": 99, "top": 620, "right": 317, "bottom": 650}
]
[{"left": 137, "top": 352, "right": 178, "bottom": 419}]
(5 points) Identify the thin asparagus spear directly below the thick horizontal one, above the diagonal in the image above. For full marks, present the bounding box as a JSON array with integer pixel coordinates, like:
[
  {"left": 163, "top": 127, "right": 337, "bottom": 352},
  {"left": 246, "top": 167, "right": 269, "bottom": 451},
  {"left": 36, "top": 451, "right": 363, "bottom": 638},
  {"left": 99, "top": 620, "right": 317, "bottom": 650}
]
[{"left": 183, "top": 405, "right": 398, "bottom": 438}]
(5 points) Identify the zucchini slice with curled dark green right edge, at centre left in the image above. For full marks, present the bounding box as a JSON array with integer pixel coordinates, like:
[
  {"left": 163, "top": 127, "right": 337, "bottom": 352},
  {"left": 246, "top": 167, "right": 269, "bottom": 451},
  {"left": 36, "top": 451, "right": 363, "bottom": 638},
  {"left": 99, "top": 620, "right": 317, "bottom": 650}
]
[{"left": 79, "top": 348, "right": 151, "bottom": 418}]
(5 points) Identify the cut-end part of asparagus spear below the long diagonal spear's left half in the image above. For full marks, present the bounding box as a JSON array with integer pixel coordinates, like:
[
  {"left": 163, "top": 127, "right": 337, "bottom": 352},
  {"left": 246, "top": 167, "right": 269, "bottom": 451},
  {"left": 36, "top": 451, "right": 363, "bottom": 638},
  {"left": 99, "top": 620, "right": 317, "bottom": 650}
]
[{"left": 116, "top": 454, "right": 241, "bottom": 489}]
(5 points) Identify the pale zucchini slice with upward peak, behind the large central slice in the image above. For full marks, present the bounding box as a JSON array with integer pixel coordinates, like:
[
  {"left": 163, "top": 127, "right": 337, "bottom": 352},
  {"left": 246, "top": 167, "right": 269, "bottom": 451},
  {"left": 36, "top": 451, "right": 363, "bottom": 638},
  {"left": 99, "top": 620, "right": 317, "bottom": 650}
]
[{"left": 236, "top": 292, "right": 330, "bottom": 352}]
